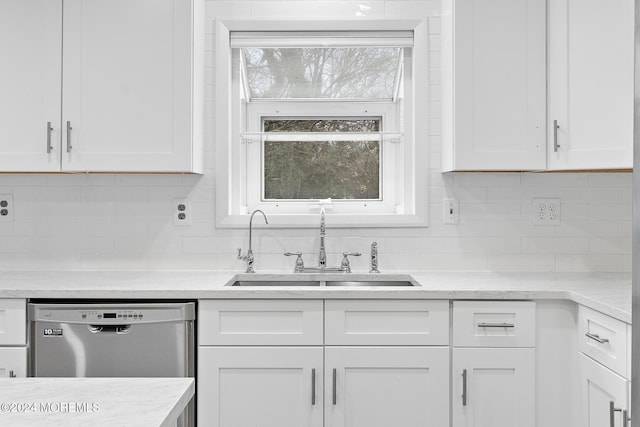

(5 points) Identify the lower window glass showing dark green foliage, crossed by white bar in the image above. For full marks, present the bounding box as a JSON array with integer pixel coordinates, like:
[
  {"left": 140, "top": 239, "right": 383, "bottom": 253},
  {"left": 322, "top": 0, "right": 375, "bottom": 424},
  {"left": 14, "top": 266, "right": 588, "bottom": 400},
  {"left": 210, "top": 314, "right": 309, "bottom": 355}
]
[{"left": 264, "top": 119, "right": 380, "bottom": 200}]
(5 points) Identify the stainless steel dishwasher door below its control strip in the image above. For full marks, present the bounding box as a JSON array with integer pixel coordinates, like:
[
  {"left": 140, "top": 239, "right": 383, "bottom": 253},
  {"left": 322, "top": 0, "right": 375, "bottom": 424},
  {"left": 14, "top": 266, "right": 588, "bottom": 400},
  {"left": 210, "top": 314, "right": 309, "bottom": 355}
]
[{"left": 31, "top": 321, "right": 193, "bottom": 377}]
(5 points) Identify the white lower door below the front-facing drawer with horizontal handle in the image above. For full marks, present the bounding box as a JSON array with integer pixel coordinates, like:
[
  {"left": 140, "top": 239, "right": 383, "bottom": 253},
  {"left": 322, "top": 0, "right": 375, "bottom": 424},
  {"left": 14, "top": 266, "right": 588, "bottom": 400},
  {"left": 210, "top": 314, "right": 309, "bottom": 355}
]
[{"left": 452, "top": 348, "right": 536, "bottom": 427}]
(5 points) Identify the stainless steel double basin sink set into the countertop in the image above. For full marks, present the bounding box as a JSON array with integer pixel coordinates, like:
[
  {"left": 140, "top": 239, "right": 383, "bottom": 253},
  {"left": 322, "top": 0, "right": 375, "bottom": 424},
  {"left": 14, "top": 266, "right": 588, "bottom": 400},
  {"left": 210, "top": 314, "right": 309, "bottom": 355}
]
[{"left": 227, "top": 273, "right": 420, "bottom": 288}]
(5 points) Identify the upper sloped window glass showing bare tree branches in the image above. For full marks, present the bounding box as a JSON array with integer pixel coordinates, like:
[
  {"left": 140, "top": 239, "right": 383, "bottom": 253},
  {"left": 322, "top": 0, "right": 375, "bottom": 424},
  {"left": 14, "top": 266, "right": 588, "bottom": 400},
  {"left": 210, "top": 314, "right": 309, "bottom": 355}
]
[{"left": 242, "top": 47, "right": 401, "bottom": 99}]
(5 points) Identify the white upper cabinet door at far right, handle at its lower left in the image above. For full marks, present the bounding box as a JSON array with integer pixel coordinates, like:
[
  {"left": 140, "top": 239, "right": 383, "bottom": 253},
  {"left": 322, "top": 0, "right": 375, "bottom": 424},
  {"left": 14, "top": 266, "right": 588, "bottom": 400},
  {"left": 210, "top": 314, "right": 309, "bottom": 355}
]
[{"left": 548, "top": 0, "right": 634, "bottom": 169}]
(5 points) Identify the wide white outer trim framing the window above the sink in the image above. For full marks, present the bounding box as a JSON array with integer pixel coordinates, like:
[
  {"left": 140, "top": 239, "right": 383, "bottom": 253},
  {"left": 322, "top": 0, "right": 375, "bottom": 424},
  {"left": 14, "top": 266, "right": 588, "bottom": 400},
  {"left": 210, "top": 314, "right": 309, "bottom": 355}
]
[{"left": 215, "top": 19, "right": 429, "bottom": 228}]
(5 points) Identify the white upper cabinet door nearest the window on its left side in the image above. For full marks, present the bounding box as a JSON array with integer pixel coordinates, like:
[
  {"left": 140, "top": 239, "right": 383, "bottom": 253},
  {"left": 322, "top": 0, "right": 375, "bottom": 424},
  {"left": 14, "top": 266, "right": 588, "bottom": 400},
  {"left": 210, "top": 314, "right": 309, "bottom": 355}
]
[{"left": 62, "top": 0, "right": 198, "bottom": 172}]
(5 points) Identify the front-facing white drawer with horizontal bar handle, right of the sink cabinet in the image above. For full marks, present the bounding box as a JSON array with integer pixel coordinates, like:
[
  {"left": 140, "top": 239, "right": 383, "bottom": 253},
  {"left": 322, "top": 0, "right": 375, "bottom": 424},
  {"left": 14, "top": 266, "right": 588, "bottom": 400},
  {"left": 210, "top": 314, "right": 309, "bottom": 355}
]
[{"left": 453, "top": 301, "right": 536, "bottom": 347}]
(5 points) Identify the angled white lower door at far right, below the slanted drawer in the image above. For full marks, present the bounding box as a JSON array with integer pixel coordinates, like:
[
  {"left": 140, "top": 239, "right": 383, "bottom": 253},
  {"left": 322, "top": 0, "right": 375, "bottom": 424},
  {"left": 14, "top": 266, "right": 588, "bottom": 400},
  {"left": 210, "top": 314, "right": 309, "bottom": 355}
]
[{"left": 580, "top": 353, "right": 629, "bottom": 427}]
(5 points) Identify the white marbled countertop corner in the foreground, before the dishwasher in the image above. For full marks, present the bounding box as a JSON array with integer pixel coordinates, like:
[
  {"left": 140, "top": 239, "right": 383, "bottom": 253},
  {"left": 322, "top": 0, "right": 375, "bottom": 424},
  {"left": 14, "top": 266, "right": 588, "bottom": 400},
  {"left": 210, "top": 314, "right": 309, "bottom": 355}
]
[{"left": 0, "top": 378, "right": 195, "bottom": 427}]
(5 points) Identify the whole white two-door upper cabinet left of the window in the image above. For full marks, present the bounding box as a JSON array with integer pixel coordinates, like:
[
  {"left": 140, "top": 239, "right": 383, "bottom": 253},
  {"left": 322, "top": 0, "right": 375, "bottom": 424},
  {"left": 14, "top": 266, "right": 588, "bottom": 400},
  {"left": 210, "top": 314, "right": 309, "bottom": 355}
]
[{"left": 0, "top": 0, "right": 203, "bottom": 172}]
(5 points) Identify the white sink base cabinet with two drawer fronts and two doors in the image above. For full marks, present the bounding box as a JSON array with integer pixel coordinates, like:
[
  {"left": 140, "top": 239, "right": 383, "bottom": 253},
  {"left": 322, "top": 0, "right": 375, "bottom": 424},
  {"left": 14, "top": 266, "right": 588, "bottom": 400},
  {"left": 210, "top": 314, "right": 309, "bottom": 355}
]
[{"left": 198, "top": 300, "right": 450, "bottom": 427}]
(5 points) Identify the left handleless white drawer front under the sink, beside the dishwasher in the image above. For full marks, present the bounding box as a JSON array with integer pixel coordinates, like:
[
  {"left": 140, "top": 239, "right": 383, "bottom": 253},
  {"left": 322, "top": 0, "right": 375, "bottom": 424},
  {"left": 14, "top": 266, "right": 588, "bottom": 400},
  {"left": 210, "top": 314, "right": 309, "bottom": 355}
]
[{"left": 198, "top": 300, "right": 322, "bottom": 345}]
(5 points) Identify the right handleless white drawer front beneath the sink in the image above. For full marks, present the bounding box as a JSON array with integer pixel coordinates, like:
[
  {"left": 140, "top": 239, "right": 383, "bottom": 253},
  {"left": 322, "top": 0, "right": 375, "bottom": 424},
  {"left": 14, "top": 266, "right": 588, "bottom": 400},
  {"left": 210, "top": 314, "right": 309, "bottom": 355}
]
[{"left": 325, "top": 300, "right": 449, "bottom": 345}]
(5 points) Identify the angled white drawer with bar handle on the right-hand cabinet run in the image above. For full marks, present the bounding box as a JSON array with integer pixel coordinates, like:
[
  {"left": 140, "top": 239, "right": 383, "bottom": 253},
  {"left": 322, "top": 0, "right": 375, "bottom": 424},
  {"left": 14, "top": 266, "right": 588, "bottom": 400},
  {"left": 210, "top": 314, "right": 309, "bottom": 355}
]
[{"left": 578, "top": 306, "right": 630, "bottom": 378}]
